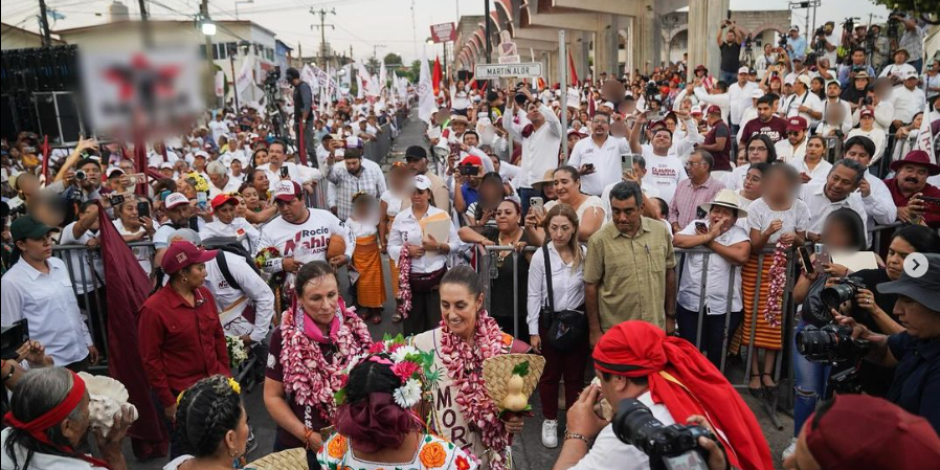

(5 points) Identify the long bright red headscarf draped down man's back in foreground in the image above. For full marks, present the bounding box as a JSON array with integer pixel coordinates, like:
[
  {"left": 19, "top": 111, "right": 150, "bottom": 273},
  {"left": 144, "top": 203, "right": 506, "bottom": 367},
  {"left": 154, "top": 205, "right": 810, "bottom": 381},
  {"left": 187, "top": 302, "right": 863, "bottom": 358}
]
[{"left": 594, "top": 321, "right": 774, "bottom": 470}]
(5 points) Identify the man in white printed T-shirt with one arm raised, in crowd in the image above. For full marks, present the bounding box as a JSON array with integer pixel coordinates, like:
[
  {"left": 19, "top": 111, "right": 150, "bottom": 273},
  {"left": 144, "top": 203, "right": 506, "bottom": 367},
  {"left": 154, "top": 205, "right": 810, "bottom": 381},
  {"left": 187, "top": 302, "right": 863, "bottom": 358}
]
[{"left": 630, "top": 114, "right": 689, "bottom": 204}]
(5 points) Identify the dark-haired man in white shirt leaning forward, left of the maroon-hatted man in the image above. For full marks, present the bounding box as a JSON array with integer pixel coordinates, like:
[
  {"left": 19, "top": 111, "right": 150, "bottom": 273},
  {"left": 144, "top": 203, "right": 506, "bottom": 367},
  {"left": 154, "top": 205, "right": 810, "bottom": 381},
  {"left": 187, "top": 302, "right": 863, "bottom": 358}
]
[{"left": 800, "top": 160, "right": 871, "bottom": 242}]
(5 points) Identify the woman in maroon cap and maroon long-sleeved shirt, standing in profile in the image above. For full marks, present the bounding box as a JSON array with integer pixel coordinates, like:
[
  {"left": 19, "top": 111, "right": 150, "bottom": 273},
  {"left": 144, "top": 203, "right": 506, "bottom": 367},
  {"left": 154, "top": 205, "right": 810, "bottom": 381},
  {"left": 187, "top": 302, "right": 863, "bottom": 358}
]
[{"left": 137, "top": 241, "right": 231, "bottom": 460}]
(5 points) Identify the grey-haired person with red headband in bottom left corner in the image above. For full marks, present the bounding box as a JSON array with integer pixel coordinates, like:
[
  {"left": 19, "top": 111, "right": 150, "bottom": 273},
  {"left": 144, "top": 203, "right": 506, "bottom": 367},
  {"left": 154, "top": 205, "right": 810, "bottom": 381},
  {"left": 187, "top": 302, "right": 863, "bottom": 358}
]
[{"left": 0, "top": 367, "right": 134, "bottom": 470}]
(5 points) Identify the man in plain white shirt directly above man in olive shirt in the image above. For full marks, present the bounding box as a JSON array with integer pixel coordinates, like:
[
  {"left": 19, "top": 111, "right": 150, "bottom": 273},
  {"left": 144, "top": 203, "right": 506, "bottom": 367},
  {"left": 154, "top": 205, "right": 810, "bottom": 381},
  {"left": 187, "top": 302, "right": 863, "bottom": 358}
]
[{"left": 568, "top": 114, "right": 630, "bottom": 196}]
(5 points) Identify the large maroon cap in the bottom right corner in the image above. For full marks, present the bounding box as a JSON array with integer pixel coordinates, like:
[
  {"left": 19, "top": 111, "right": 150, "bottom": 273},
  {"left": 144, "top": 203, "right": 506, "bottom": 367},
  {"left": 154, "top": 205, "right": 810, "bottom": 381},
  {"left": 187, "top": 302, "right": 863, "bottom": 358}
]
[{"left": 806, "top": 395, "right": 940, "bottom": 470}]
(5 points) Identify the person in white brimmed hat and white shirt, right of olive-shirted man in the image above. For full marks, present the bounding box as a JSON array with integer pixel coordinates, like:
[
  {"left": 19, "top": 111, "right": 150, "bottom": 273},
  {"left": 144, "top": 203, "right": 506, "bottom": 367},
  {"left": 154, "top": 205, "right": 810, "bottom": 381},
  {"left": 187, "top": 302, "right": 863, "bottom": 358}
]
[{"left": 673, "top": 189, "right": 751, "bottom": 367}]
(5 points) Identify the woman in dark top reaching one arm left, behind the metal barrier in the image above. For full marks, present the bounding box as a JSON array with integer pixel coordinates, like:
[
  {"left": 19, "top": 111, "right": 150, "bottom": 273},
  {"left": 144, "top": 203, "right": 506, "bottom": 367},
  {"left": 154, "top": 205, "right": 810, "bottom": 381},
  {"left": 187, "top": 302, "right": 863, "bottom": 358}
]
[{"left": 459, "top": 199, "right": 532, "bottom": 334}]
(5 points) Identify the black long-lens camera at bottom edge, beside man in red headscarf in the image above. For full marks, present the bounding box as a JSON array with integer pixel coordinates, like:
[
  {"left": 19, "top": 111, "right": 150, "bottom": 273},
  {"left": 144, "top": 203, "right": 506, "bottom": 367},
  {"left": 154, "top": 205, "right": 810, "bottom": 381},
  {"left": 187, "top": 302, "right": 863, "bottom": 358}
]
[{"left": 613, "top": 398, "right": 721, "bottom": 470}]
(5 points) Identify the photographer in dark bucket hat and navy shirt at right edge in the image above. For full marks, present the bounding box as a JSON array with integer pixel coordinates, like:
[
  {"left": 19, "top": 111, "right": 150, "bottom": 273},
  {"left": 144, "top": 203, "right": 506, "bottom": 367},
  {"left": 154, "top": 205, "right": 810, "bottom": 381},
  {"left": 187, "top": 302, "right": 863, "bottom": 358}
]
[{"left": 836, "top": 254, "right": 940, "bottom": 433}]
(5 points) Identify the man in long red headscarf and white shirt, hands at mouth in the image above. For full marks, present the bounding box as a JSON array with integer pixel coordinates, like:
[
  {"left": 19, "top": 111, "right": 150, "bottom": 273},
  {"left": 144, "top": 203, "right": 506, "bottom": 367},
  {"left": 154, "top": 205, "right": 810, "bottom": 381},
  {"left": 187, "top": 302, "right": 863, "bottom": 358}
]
[{"left": 554, "top": 321, "right": 773, "bottom": 470}]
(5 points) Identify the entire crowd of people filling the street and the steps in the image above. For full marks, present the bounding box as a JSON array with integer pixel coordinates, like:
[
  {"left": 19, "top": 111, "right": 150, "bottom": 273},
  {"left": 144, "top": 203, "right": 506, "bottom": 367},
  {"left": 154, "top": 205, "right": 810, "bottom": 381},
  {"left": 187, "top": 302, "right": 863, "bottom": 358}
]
[{"left": 0, "top": 14, "right": 940, "bottom": 470}]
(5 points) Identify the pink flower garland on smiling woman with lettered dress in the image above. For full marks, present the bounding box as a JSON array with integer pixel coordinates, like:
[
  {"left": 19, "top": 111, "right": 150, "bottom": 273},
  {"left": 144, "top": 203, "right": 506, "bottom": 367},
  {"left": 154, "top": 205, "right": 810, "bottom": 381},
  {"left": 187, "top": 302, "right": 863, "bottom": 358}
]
[{"left": 441, "top": 310, "right": 509, "bottom": 470}]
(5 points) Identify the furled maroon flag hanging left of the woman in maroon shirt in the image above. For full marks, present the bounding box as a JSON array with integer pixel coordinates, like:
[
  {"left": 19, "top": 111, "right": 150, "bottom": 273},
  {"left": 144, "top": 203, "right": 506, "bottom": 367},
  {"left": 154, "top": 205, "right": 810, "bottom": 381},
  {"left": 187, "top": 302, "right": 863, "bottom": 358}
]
[{"left": 98, "top": 203, "right": 169, "bottom": 458}]
